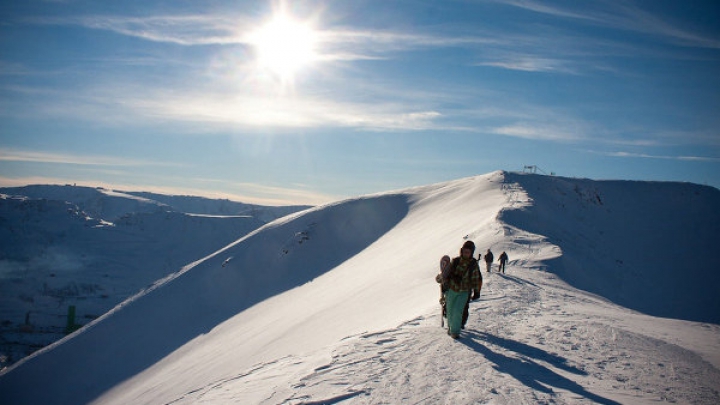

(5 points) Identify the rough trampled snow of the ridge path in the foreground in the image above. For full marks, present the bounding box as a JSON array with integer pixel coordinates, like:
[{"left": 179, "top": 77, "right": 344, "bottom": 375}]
[{"left": 224, "top": 267, "right": 720, "bottom": 405}]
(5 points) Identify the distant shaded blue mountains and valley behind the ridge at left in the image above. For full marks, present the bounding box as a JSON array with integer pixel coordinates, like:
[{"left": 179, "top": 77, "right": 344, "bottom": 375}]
[{"left": 0, "top": 186, "right": 307, "bottom": 366}]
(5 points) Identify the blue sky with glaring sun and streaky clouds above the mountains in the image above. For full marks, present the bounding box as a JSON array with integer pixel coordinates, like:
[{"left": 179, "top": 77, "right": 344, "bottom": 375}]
[{"left": 0, "top": 0, "right": 720, "bottom": 205}]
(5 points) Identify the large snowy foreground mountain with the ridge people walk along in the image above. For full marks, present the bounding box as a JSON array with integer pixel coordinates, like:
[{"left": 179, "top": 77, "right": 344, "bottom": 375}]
[{"left": 0, "top": 172, "right": 720, "bottom": 404}]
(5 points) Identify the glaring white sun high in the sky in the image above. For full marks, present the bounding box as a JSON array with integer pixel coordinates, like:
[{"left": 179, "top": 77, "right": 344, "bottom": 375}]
[{"left": 250, "top": 13, "right": 317, "bottom": 82}]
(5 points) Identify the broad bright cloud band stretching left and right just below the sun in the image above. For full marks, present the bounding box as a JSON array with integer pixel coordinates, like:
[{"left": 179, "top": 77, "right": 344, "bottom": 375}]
[{"left": 0, "top": 65, "right": 444, "bottom": 131}]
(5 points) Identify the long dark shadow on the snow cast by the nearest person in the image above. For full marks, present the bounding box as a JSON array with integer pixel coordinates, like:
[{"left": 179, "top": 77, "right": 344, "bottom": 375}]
[{"left": 459, "top": 331, "right": 620, "bottom": 405}]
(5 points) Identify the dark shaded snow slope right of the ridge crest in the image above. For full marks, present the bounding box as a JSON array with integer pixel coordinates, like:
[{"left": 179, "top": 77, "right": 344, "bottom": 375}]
[{"left": 500, "top": 173, "right": 720, "bottom": 323}]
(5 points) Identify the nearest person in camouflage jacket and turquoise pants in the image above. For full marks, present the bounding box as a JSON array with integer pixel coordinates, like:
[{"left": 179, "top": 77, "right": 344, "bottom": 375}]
[{"left": 445, "top": 241, "right": 482, "bottom": 339}]
